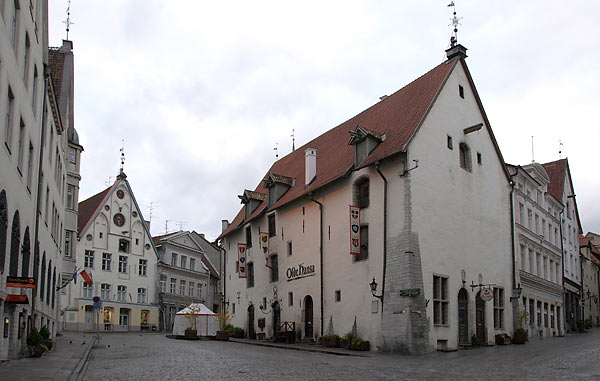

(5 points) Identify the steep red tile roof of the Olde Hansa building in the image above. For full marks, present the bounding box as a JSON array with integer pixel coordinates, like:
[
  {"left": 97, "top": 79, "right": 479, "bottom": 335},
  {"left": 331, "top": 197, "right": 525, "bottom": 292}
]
[{"left": 219, "top": 59, "right": 458, "bottom": 238}]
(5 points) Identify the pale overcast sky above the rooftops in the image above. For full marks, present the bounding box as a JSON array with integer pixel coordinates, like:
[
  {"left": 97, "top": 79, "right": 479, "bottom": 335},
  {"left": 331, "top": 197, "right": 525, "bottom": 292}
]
[{"left": 49, "top": 0, "right": 600, "bottom": 239}]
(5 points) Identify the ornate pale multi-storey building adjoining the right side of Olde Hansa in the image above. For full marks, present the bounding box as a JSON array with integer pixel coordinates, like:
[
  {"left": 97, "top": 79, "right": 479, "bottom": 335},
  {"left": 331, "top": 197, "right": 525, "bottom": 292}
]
[{"left": 509, "top": 163, "right": 564, "bottom": 338}]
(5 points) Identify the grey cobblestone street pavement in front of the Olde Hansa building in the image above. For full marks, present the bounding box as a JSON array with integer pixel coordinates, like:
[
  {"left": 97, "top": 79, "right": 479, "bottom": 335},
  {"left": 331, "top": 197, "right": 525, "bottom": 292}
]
[{"left": 84, "top": 328, "right": 600, "bottom": 380}]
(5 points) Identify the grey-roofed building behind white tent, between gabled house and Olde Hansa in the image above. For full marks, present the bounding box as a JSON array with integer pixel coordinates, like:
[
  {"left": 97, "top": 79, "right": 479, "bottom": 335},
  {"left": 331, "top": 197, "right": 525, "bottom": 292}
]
[{"left": 153, "top": 231, "right": 220, "bottom": 331}]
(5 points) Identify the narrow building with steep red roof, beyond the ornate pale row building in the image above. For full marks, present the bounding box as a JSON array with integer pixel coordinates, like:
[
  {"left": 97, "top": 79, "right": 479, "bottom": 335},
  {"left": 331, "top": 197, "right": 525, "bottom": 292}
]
[{"left": 542, "top": 159, "right": 583, "bottom": 332}]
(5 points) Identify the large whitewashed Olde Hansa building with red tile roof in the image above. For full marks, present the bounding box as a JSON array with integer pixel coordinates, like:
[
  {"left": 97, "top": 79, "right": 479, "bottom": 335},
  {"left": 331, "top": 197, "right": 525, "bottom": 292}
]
[{"left": 219, "top": 45, "right": 514, "bottom": 353}]
